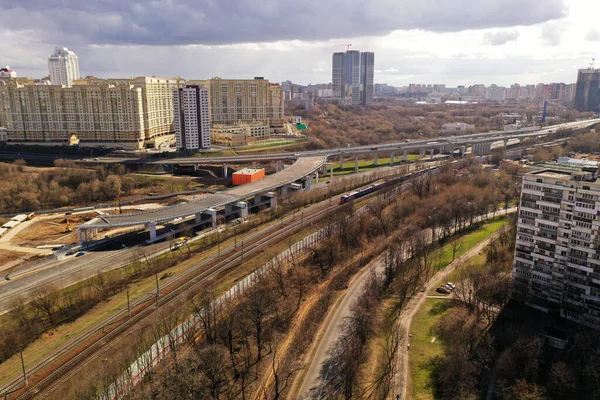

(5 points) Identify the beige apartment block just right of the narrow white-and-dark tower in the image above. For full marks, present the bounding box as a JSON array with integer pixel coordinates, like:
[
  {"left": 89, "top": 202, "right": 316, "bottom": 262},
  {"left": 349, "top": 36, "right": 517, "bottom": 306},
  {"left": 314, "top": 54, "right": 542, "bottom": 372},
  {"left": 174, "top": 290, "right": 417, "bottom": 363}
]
[{"left": 195, "top": 77, "right": 284, "bottom": 124}]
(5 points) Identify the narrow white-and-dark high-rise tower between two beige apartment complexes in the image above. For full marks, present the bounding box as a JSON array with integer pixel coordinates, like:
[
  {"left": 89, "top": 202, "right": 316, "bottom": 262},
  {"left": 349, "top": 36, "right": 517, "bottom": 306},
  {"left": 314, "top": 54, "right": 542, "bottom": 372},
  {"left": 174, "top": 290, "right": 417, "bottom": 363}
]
[{"left": 173, "top": 85, "right": 210, "bottom": 150}]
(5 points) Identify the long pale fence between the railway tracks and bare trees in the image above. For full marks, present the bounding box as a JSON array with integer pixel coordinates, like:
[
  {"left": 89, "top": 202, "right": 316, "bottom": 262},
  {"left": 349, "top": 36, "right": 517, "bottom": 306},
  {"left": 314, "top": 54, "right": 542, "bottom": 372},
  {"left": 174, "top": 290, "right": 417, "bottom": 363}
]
[{"left": 98, "top": 227, "right": 330, "bottom": 400}]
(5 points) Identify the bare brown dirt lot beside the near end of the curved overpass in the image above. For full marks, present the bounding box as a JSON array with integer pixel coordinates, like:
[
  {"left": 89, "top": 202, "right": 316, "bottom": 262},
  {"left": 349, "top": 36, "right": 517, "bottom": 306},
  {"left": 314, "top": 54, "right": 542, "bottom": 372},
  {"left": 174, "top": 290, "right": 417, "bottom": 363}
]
[{"left": 10, "top": 213, "right": 97, "bottom": 247}]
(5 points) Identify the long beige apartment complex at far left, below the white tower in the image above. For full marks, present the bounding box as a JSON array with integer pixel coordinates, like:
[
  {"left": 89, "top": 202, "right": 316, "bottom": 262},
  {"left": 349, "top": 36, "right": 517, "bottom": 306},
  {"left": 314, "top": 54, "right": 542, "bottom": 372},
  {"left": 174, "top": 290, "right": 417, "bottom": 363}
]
[{"left": 0, "top": 77, "right": 184, "bottom": 148}]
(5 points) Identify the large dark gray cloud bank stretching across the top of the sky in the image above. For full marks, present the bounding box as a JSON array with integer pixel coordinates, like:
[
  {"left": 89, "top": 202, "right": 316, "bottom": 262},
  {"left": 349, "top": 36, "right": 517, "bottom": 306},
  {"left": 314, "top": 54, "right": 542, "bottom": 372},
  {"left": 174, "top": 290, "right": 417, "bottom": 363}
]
[{"left": 0, "top": 0, "right": 566, "bottom": 45}]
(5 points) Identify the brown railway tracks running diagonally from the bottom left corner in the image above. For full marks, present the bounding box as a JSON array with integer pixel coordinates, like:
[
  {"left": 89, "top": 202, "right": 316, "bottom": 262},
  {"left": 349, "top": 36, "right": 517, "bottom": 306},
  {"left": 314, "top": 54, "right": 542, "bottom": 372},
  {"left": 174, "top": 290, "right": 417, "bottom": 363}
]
[{"left": 8, "top": 200, "right": 335, "bottom": 399}]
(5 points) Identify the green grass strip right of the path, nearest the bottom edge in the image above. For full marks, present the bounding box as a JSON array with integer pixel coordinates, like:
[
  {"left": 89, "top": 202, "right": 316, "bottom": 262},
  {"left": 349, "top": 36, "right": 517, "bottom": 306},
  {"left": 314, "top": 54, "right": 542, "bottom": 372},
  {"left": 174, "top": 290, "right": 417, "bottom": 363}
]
[{"left": 409, "top": 299, "right": 452, "bottom": 400}]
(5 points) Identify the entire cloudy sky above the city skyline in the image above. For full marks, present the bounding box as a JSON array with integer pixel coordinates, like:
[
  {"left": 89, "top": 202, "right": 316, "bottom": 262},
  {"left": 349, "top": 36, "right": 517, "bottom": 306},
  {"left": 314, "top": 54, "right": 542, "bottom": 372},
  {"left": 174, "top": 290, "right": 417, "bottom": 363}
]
[{"left": 0, "top": 0, "right": 600, "bottom": 86}]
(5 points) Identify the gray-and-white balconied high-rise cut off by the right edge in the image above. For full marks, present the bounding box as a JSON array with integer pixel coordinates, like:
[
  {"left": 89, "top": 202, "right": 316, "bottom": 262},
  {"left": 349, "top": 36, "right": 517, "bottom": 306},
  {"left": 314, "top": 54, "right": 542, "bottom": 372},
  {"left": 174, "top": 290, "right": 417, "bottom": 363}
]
[{"left": 513, "top": 160, "right": 600, "bottom": 329}]
